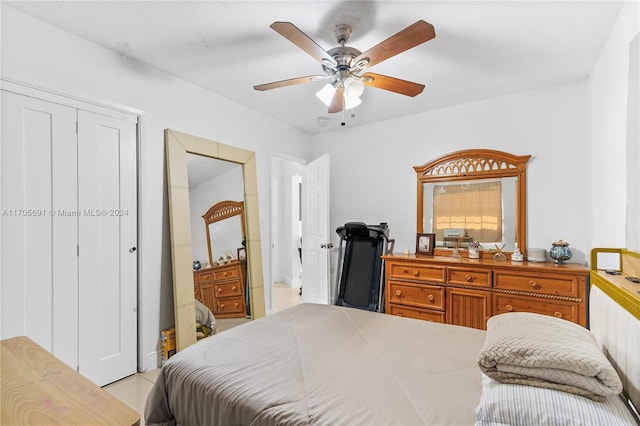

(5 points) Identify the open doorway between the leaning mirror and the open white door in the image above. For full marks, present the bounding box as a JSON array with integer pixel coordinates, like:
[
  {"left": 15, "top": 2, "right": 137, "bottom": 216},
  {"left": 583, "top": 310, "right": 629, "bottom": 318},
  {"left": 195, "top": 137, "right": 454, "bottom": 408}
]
[{"left": 271, "top": 156, "right": 306, "bottom": 312}]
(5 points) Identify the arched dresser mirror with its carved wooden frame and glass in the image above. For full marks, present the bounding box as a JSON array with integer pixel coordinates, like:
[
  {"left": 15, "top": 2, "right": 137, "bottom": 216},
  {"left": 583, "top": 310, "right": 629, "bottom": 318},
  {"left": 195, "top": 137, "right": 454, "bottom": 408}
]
[{"left": 414, "top": 149, "right": 530, "bottom": 257}]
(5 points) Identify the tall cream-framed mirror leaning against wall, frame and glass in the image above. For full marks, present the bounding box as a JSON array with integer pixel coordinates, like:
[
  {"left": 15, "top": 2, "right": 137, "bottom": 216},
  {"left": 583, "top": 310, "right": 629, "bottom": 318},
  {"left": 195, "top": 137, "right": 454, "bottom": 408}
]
[{"left": 165, "top": 129, "right": 265, "bottom": 351}]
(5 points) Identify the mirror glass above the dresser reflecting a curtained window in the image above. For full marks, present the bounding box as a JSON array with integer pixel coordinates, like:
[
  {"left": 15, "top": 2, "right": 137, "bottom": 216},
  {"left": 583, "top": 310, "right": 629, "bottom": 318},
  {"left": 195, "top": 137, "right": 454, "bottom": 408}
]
[{"left": 422, "top": 177, "right": 518, "bottom": 251}]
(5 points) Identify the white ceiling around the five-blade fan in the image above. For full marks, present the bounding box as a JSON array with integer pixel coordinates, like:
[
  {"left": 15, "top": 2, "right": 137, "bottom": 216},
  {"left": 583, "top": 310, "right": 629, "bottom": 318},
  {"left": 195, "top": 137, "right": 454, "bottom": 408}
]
[{"left": 5, "top": 1, "right": 622, "bottom": 133}]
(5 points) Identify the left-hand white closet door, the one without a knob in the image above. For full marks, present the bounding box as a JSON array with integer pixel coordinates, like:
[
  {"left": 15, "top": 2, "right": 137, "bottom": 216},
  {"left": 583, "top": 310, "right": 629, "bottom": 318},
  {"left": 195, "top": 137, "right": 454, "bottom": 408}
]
[{"left": 0, "top": 91, "right": 78, "bottom": 369}]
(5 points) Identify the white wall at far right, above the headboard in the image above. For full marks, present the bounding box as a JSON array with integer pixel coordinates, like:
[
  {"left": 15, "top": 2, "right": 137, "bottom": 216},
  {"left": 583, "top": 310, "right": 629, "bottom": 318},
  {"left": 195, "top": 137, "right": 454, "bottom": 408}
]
[{"left": 585, "top": 2, "right": 640, "bottom": 251}]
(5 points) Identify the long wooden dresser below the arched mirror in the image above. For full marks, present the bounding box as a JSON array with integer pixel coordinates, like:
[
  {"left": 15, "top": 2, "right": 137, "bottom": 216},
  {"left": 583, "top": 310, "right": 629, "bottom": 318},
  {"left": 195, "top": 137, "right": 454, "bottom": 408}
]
[{"left": 383, "top": 254, "right": 589, "bottom": 329}]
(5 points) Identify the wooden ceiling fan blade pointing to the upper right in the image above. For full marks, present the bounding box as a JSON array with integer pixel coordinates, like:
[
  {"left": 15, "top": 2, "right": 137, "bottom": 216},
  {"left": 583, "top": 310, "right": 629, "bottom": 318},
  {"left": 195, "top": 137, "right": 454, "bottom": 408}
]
[{"left": 351, "top": 20, "right": 436, "bottom": 69}]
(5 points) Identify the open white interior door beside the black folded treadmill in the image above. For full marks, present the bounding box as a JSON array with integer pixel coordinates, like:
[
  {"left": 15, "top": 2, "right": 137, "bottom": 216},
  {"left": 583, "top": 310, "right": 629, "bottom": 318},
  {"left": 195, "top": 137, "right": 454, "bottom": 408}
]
[{"left": 302, "top": 154, "right": 331, "bottom": 304}]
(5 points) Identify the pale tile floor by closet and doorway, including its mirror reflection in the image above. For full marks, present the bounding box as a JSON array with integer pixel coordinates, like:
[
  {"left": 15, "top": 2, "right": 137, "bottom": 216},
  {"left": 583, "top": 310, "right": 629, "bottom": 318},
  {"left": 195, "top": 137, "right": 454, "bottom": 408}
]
[{"left": 104, "top": 283, "right": 302, "bottom": 425}]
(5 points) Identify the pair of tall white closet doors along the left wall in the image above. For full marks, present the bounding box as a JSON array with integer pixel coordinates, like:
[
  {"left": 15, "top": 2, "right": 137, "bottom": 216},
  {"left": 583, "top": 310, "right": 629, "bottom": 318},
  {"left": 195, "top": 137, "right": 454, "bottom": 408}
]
[{"left": 0, "top": 90, "right": 138, "bottom": 386}]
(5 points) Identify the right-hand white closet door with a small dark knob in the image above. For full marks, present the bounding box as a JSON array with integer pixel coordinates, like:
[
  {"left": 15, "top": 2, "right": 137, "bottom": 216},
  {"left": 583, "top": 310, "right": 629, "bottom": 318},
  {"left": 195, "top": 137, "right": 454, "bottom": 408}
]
[{"left": 78, "top": 111, "right": 137, "bottom": 386}]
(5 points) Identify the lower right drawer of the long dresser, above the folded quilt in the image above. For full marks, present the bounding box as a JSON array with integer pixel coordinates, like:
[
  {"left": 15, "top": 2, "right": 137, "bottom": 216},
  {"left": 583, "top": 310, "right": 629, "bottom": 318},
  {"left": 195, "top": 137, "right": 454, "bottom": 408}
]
[{"left": 494, "top": 294, "right": 579, "bottom": 323}]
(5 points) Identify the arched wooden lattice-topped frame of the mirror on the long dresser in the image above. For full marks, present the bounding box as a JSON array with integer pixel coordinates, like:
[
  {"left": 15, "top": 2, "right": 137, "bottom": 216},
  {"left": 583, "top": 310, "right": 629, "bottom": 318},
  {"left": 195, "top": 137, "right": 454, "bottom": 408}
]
[{"left": 413, "top": 149, "right": 531, "bottom": 257}]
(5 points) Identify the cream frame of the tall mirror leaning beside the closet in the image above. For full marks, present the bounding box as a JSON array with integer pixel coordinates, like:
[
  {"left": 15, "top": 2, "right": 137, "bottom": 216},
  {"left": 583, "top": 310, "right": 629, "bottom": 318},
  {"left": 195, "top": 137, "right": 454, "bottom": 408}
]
[{"left": 164, "top": 129, "right": 266, "bottom": 351}]
